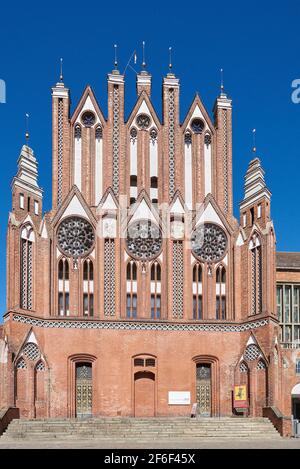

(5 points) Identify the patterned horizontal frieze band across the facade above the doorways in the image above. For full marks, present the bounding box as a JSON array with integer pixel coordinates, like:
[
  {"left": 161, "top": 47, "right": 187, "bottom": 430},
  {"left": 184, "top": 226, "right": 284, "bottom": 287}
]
[{"left": 12, "top": 314, "right": 270, "bottom": 332}]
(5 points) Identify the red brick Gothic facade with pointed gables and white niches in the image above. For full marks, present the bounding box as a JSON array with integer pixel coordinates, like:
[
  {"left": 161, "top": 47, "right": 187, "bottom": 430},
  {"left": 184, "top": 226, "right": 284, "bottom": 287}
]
[{"left": 0, "top": 66, "right": 300, "bottom": 418}]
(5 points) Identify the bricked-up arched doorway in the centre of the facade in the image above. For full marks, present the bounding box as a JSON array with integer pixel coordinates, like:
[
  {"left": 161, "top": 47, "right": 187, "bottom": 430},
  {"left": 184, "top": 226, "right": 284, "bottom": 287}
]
[{"left": 134, "top": 371, "right": 155, "bottom": 417}]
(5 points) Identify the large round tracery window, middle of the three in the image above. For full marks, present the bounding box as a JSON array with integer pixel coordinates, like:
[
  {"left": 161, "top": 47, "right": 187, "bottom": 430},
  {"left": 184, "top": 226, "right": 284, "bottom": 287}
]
[{"left": 126, "top": 220, "right": 162, "bottom": 261}]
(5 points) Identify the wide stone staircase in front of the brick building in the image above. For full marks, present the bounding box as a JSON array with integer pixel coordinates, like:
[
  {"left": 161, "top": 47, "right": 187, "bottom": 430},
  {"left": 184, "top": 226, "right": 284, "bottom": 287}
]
[{"left": 0, "top": 418, "right": 280, "bottom": 443}]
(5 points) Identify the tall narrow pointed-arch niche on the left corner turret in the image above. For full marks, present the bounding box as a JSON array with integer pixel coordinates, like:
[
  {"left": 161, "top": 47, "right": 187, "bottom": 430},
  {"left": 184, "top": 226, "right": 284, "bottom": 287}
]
[{"left": 20, "top": 225, "right": 35, "bottom": 310}]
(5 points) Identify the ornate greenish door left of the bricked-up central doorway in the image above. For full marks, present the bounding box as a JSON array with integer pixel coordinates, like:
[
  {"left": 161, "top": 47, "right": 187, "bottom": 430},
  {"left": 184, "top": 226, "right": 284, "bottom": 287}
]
[{"left": 76, "top": 363, "right": 93, "bottom": 418}]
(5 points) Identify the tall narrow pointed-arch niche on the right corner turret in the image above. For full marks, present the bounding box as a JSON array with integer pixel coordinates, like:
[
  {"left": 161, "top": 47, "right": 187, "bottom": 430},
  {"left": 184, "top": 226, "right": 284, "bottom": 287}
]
[{"left": 250, "top": 234, "right": 262, "bottom": 316}]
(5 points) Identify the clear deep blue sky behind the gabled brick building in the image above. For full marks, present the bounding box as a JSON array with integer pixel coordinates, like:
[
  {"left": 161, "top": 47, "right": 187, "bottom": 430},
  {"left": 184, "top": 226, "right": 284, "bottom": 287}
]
[{"left": 0, "top": 0, "right": 300, "bottom": 312}]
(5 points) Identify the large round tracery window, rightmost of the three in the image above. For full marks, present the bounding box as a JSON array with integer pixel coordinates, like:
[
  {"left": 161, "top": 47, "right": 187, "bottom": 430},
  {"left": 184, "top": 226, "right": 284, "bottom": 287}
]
[{"left": 191, "top": 223, "right": 228, "bottom": 263}]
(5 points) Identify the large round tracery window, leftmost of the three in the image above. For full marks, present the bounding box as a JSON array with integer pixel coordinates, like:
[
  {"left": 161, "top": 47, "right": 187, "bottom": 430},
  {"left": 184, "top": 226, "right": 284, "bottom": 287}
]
[{"left": 57, "top": 217, "right": 95, "bottom": 257}]
